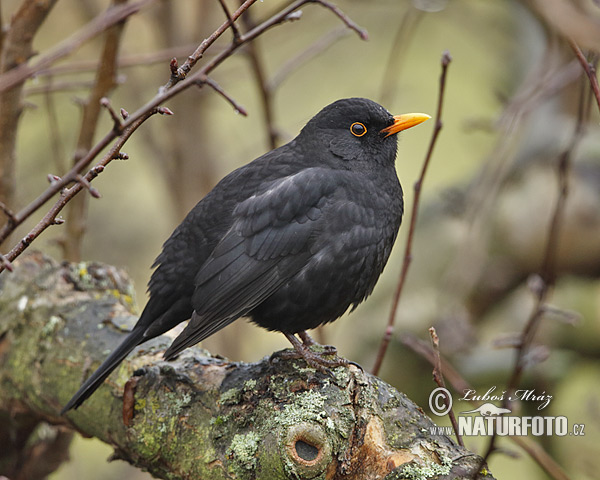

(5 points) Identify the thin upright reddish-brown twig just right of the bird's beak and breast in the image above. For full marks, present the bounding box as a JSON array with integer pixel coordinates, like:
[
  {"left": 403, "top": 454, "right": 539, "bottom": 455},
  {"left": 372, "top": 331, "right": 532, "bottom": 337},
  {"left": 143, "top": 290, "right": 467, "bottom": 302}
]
[{"left": 372, "top": 51, "right": 452, "bottom": 375}]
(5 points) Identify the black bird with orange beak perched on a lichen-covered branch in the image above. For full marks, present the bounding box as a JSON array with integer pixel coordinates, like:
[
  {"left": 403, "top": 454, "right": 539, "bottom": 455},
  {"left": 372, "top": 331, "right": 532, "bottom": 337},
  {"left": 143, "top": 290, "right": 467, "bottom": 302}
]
[{"left": 62, "top": 98, "right": 430, "bottom": 413}]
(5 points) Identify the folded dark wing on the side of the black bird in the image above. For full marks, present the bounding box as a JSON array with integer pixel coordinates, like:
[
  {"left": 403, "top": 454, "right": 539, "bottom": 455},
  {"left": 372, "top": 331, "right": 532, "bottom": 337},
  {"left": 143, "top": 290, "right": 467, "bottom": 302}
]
[{"left": 165, "top": 168, "right": 336, "bottom": 359}]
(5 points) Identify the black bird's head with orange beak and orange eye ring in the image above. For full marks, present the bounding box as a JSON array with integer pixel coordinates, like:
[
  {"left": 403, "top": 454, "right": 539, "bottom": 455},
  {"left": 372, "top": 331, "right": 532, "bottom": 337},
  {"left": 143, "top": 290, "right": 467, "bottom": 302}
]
[{"left": 301, "top": 98, "right": 431, "bottom": 163}]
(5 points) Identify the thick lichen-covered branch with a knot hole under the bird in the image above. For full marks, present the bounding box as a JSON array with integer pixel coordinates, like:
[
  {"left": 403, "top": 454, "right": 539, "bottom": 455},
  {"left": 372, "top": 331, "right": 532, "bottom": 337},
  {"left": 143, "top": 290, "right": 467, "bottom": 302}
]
[{"left": 0, "top": 253, "right": 492, "bottom": 480}]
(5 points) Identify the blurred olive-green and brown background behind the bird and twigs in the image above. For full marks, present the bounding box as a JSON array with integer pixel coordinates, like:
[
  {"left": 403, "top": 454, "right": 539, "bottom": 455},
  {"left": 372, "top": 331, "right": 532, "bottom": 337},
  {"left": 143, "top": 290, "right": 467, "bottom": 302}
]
[{"left": 0, "top": 0, "right": 600, "bottom": 480}]
